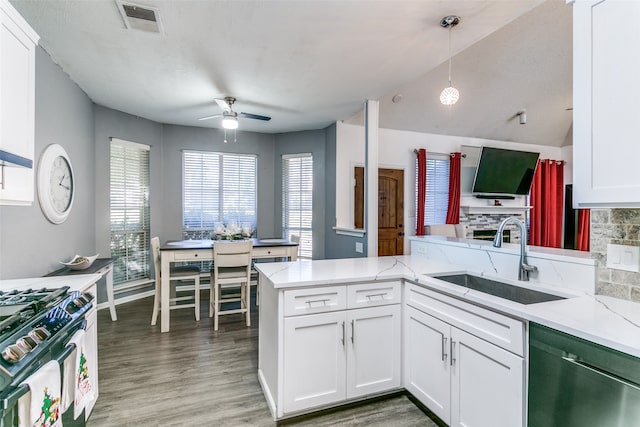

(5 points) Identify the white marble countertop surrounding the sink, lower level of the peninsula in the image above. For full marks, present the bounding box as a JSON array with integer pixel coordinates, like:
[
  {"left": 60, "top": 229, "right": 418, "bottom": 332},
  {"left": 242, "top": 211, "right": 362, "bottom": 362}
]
[{"left": 256, "top": 255, "right": 640, "bottom": 357}]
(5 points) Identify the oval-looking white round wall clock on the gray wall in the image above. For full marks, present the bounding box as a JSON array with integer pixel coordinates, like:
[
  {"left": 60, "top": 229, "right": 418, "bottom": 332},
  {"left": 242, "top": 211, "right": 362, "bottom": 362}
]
[{"left": 38, "top": 144, "right": 75, "bottom": 224}]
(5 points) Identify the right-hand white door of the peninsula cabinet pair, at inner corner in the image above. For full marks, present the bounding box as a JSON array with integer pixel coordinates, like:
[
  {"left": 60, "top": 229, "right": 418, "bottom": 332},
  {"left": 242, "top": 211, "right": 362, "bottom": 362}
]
[{"left": 347, "top": 304, "right": 401, "bottom": 398}]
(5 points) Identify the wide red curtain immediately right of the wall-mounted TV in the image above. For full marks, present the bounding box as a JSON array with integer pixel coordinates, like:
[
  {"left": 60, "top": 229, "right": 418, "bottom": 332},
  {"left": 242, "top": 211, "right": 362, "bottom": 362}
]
[{"left": 529, "top": 159, "right": 564, "bottom": 248}]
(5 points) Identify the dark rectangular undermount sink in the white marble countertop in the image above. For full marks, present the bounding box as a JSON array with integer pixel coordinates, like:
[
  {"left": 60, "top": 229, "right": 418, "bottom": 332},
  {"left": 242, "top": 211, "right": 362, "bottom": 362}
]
[{"left": 434, "top": 274, "right": 566, "bottom": 304}]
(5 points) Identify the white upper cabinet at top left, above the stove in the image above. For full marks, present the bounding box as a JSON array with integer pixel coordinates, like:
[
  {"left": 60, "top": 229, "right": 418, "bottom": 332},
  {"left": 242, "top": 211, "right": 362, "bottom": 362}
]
[{"left": 0, "top": 0, "right": 38, "bottom": 205}]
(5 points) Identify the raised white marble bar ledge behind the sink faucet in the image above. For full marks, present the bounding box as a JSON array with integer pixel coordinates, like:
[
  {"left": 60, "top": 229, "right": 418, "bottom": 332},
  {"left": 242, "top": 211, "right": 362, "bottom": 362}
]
[{"left": 408, "top": 236, "right": 596, "bottom": 265}]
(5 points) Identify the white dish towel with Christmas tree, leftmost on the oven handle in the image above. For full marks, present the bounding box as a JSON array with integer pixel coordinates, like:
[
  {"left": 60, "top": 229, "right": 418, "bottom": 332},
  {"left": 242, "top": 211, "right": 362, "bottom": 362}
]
[{"left": 18, "top": 360, "right": 62, "bottom": 427}]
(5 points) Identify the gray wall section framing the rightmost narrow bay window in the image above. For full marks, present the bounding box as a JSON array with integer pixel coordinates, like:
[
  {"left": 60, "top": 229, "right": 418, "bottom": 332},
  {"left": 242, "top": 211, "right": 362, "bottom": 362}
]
[{"left": 273, "top": 129, "right": 328, "bottom": 259}]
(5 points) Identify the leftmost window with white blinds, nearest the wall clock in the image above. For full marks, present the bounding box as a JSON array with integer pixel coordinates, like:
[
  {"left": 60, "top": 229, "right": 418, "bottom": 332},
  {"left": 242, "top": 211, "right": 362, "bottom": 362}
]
[{"left": 110, "top": 138, "right": 151, "bottom": 284}]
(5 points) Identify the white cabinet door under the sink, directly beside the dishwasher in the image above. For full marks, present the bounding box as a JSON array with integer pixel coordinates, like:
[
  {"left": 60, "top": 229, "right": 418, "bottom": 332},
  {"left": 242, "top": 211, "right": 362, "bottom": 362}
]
[{"left": 449, "top": 327, "right": 524, "bottom": 427}]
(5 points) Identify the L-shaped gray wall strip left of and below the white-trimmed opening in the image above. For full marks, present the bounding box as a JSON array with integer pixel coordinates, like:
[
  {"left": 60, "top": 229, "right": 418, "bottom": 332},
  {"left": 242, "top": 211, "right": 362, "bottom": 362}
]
[{"left": 324, "top": 125, "right": 367, "bottom": 259}]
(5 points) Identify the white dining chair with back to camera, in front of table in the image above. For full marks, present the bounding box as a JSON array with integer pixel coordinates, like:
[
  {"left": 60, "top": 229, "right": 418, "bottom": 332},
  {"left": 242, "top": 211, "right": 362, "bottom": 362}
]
[{"left": 209, "top": 240, "right": 253, "bottom": 331}]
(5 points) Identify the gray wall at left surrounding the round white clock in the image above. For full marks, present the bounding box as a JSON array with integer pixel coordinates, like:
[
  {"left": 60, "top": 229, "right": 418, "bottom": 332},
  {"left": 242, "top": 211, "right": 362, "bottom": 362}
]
[{"left": 0, "top": 47, "right": 96, "bottom": 279}]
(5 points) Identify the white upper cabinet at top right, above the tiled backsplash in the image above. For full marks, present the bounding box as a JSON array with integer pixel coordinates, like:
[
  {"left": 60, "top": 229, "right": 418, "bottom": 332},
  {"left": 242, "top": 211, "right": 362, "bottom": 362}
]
[{"left": 573, "top": 0, "right": 640, "bottom": 208}]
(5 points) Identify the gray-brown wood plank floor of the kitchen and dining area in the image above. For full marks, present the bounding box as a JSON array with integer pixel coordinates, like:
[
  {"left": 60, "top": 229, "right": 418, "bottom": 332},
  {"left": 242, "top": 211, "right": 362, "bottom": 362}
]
[{"left": 88, "top": 292, "right": 436, "bottom": 427}]
